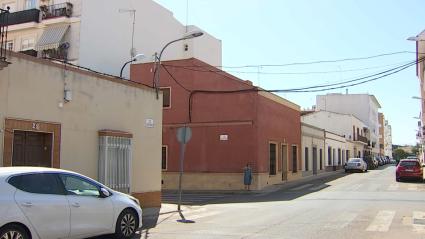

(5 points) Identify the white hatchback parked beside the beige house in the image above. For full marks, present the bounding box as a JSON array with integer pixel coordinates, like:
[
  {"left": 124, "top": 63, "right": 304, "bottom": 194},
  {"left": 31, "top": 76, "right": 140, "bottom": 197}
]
[{"left": 0, "top": 167, "right": 142, "bottom": 239}]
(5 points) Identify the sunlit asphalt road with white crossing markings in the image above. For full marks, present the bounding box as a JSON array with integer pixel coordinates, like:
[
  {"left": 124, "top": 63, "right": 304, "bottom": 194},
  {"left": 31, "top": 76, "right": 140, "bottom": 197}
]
[{"left": 141, "top": 166, "right": 425, "bottom": 239}]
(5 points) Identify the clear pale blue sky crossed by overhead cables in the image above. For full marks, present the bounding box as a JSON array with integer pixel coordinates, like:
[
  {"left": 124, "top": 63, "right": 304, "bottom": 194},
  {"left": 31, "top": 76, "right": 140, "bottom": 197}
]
[{"left": 157, "top": 0, "right": 425, "bottom": 144}]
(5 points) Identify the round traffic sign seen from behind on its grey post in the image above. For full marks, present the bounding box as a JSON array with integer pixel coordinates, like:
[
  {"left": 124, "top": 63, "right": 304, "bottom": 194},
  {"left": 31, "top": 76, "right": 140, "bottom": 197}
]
[{"left": 177, "top": 126, "right": 194, "bottom": 223}]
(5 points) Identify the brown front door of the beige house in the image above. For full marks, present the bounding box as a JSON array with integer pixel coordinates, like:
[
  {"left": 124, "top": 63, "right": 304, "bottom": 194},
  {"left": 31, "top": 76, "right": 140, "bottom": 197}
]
[{"left": 12, "top": 130, "right": 52, "bottom": 167}]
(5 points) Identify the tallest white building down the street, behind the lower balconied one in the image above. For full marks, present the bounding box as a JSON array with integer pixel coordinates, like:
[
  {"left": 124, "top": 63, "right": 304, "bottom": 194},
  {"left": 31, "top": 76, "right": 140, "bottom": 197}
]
[{"left": 316, "top": 94, "right": 381, "bottom": 155}]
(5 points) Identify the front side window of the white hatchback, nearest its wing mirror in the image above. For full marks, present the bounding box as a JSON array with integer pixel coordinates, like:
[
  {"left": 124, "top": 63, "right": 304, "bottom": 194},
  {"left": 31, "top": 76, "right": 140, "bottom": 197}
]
[{"left": 60, "top": 174, "right": 100, "bottom": 197}]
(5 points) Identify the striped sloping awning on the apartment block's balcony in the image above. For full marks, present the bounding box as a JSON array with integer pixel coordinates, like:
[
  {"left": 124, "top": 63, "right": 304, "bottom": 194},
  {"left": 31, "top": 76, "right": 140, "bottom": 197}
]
[{"left": 34, "top": 25, "right": 69, "bottom": 51}]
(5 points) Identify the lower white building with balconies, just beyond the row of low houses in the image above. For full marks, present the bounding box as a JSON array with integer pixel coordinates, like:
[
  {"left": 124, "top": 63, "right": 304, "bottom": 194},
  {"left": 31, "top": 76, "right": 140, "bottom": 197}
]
[{"left": 301, "top": 111, "right": 368, "bottom": 158}]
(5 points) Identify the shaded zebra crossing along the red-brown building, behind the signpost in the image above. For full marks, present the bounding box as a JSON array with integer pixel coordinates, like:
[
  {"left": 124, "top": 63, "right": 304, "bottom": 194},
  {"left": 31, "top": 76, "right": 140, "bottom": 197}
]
[{"left": 161, "top": 192, "right": 229, "bottom": 205}]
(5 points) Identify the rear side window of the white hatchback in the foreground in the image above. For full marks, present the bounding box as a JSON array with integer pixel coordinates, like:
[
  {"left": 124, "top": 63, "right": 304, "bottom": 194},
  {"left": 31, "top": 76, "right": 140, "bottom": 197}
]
[{"left": 9, "top": 173, "right": 64, "bottom": 195}]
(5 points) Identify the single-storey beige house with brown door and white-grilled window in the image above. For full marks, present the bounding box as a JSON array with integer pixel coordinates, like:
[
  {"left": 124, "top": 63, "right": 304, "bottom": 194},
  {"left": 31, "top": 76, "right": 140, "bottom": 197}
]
[{"left": 0, "top": 53, "right": 162, "bottom": 207}]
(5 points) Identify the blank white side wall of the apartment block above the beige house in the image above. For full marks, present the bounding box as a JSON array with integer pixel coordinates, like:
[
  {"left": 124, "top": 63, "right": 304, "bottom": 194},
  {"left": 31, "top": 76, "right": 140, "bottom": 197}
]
[{"left": 79, "top": 0, "right": 221, "bottom": 77}]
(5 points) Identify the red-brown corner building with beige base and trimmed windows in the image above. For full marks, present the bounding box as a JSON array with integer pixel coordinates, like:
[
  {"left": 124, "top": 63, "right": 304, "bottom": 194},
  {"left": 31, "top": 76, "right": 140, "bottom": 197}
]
[{"left": 131, "top": 58, "right": 301, "bottom": 190}]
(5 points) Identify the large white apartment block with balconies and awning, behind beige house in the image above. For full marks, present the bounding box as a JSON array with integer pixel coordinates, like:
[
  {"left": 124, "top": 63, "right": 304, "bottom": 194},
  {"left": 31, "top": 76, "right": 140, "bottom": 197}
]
[{"left": 0, "top": 0, "right": 221, "bottom": 77}]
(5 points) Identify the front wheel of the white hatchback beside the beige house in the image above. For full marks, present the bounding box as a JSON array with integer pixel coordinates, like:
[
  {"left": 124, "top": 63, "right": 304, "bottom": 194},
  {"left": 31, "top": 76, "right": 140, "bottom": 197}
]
[{"left": 114, "top": 209, "right": 139, "bottom": 239}]
